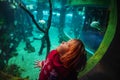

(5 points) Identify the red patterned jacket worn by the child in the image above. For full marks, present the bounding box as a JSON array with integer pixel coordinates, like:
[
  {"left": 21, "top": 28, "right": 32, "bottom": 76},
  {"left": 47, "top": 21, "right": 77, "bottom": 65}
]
[{"left": 39, "top": 50, "right": 77, "bottom": 80}]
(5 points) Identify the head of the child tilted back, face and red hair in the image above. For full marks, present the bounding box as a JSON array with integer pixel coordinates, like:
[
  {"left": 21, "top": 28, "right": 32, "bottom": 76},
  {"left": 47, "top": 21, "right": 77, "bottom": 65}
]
[{"left": 57, "top": 39, "right": 87, "bottom": 71}]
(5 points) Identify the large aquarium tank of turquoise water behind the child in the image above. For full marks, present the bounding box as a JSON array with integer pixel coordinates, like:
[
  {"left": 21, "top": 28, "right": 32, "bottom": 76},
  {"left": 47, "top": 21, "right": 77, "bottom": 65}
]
[{"left": 0, "top": 0, "right": 112, "bottom": 80}]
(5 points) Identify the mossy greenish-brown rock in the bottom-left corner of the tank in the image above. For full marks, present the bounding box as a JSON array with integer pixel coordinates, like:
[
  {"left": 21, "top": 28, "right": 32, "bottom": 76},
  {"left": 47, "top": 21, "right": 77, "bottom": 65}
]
[{"left": 0, "top": 64, "right": 29, "bottom": 80}]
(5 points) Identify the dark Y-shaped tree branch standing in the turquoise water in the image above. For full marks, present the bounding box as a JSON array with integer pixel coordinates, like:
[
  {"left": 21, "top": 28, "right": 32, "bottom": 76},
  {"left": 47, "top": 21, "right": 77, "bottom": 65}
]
[{"left": 19, "top": 0, "right": 52, "bottom": 55}]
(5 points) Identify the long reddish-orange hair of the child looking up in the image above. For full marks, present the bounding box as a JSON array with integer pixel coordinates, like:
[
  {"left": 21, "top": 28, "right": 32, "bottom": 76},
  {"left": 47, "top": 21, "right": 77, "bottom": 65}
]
[{"left": 60, "top": 39, "right": 87, "bottom": 71}]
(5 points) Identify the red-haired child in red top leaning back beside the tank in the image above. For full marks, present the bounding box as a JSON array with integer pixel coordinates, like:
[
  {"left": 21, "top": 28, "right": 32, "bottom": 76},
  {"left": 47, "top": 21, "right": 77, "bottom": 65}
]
[{"left": 35, "top": 39, "right": 87, "bottom": 80}]
